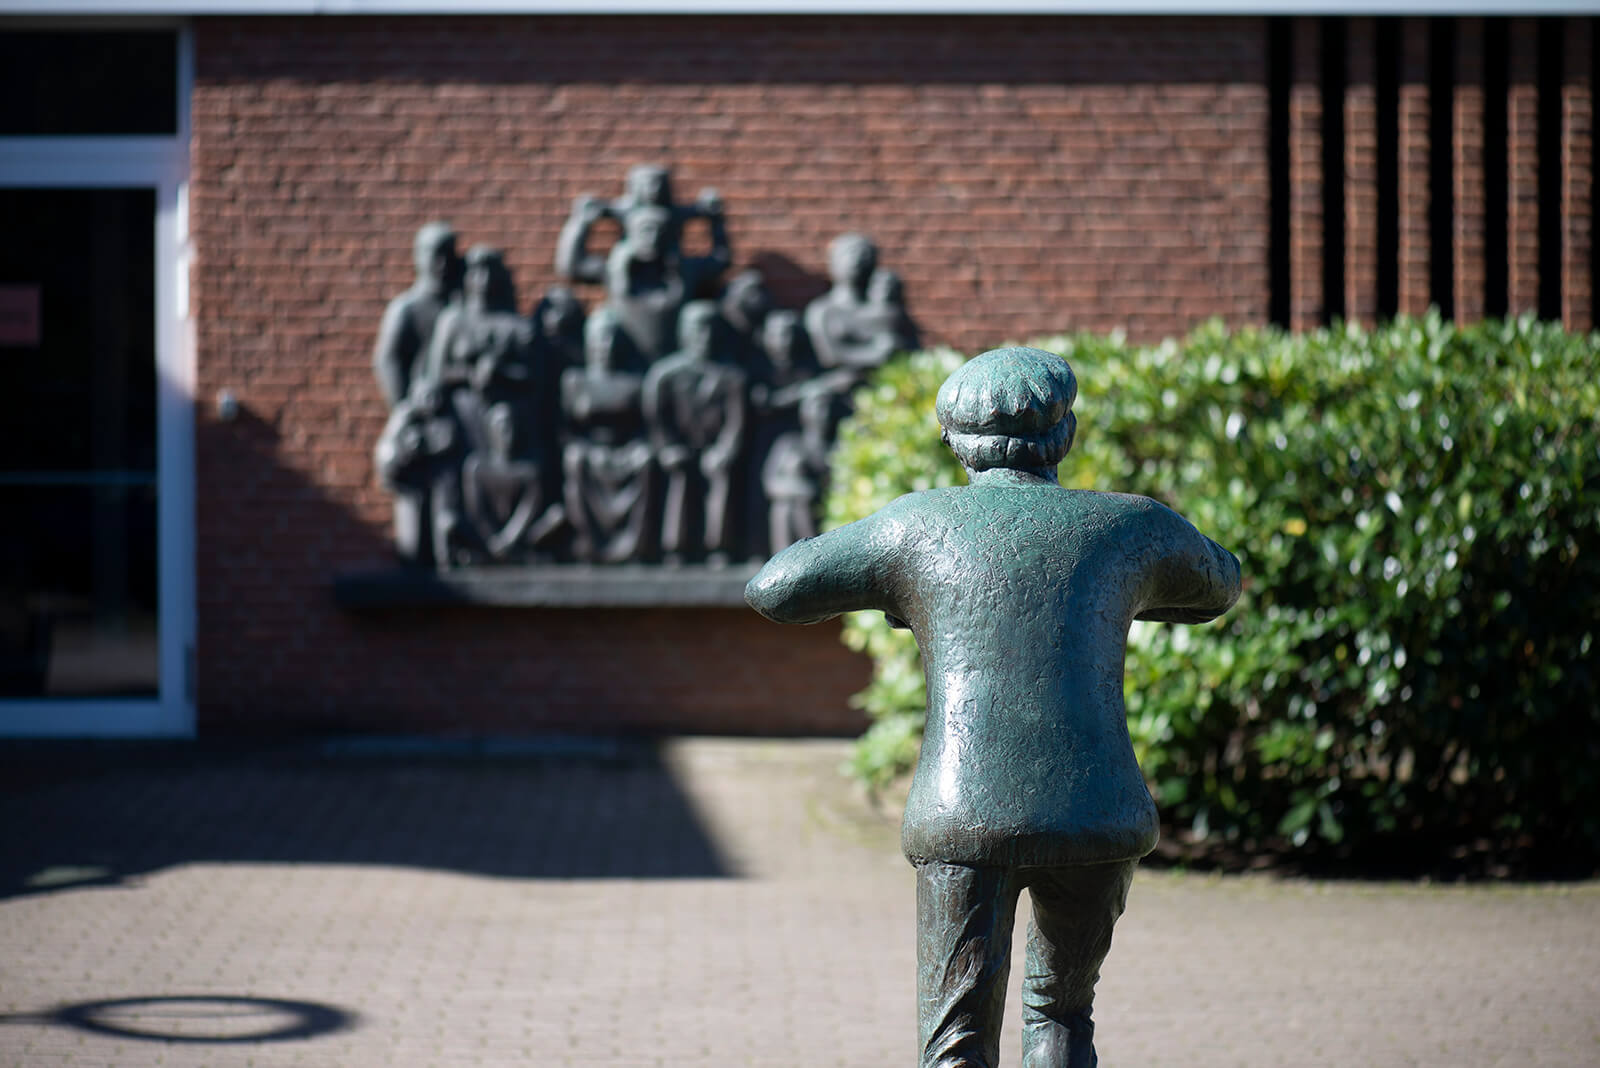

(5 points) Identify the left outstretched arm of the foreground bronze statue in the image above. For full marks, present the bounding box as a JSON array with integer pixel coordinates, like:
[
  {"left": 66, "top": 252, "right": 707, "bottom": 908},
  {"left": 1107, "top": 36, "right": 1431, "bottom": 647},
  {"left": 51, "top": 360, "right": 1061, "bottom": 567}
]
[{"left": 744, "top": 513, "right": 901, "bottom": 624}]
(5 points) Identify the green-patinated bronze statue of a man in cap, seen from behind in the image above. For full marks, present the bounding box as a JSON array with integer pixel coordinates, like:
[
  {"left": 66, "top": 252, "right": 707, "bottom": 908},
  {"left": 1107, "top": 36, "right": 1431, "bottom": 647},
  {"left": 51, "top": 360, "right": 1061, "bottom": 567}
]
[{"left": 746, "top": 349, "right": 1238, "bottom": 1068}]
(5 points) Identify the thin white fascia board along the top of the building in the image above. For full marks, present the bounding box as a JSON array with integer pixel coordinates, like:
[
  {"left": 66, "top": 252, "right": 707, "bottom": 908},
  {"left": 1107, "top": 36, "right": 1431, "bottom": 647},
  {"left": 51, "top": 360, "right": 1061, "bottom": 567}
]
[{"left": 9, "top": 0, "right": 1600, "bottom": 18}]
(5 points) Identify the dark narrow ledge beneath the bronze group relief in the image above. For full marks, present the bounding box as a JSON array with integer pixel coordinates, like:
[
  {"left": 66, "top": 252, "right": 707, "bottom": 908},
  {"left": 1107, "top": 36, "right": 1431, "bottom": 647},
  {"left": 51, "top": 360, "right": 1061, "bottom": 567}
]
[{"left": 333, "top": 564, "right": 757, "bottom": 611}]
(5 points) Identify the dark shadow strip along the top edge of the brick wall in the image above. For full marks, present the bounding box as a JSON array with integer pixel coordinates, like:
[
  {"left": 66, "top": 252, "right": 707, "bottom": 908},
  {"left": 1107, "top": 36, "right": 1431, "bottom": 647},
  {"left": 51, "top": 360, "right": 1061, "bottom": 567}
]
[{"left": 209, "top": 13, "right": 1266, "bottom": 86}]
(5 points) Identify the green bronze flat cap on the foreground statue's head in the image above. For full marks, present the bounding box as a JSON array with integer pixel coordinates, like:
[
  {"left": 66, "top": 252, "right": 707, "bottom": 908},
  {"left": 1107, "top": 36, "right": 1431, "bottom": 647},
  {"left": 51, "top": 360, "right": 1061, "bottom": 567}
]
[{"left": 934, "top": 347, "right": 1078, "bottom": 436}]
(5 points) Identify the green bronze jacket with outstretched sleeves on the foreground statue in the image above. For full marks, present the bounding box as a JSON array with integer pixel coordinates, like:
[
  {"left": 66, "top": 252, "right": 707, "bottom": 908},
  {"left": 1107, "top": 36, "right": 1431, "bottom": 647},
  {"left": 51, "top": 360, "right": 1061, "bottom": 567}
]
[{"left": 746, "top": 470, "right": 1240, "bottom": 867}]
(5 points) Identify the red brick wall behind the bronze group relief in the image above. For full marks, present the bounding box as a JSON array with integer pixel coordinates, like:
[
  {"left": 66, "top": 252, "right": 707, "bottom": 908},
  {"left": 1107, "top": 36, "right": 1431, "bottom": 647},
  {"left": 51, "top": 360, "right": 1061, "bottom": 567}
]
[{"left": 192, "top": 18, "right": 1269, "bottom": 732}]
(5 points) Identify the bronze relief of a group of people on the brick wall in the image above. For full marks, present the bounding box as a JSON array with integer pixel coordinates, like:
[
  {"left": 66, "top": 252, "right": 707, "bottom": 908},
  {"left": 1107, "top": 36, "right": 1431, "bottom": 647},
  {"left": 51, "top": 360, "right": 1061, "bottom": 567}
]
[{"left": 373, "top": 165, "right": 915, "bottom": 569}]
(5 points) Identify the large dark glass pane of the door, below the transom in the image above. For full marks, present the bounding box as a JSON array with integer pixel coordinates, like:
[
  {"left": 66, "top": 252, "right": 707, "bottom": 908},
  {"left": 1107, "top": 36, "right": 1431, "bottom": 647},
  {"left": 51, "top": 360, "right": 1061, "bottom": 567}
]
[{"left": 0, "top": 189, "right": 158, "bottom": 697}]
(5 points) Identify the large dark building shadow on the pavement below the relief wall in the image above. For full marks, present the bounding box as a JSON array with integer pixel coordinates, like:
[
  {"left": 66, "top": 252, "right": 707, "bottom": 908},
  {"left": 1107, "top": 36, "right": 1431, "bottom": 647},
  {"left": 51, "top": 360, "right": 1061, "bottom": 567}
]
[{"left": 0, "top": 740, "right": 736, "bottom": 897}]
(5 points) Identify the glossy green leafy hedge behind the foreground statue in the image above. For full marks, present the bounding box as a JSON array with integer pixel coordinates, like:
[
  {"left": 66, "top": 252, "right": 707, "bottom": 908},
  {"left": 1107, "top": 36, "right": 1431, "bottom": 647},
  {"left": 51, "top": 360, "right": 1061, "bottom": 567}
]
[{"left": 827, "top": 317, "right": 1600, "bottom": 855}]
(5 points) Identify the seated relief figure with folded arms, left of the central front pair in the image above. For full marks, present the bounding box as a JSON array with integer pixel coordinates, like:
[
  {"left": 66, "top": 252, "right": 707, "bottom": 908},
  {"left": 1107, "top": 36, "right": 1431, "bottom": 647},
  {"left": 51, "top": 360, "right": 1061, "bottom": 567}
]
[{"left": 562, "top": 307, "right": 656, "bottom": 563}]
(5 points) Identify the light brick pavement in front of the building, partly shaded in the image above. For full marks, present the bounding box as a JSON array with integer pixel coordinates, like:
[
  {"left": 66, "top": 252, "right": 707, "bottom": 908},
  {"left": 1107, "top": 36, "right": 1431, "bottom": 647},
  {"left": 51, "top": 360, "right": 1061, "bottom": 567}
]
[{"left": 0, "top": 740, "right": 1600, "bottom": 1068}]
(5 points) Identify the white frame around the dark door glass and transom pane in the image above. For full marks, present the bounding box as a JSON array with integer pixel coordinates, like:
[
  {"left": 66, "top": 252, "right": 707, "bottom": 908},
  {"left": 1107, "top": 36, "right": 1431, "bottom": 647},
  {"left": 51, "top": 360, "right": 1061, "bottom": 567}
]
[{"left": 0, "top": 19, "right": 195, "bottom": 737}]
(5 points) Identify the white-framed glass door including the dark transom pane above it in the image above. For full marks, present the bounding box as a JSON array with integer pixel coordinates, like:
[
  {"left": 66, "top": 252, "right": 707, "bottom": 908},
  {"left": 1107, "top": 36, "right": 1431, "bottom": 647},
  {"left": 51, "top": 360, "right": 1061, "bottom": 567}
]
[{"left": 0, "top": 16, "right": 195, "bottom": 737}]
